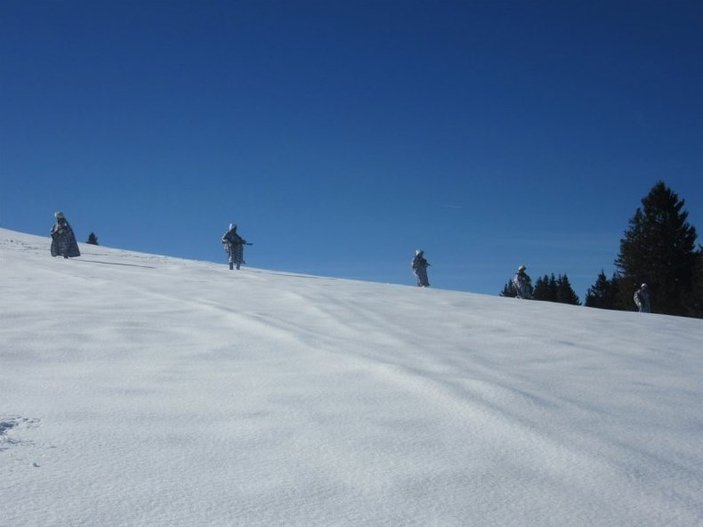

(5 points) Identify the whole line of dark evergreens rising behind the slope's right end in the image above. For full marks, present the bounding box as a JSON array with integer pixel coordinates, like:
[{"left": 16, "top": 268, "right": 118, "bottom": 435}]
[{"left": 500, "top": 181, "right": 703, "bottom": 318}]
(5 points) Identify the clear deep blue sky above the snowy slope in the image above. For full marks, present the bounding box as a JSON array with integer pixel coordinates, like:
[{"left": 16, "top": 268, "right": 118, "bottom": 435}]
[{"left": 0, "top": 0, "right": 703, "bottom": 300}]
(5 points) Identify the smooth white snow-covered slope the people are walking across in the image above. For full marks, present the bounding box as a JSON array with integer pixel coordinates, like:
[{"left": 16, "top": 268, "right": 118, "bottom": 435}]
[{"left": 0, "top": 229, "right": 703, "bottom": 527}]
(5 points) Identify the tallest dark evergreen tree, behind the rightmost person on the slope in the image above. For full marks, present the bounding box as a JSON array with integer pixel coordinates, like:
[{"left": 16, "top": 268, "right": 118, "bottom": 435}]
[{"left": 615, "top": 181, "right": 697, "bottom": 315}]
